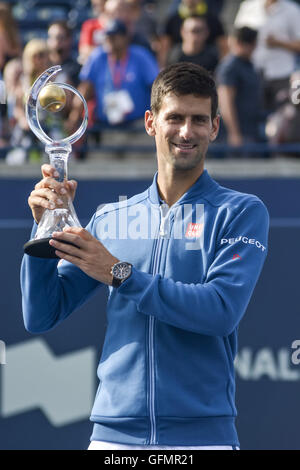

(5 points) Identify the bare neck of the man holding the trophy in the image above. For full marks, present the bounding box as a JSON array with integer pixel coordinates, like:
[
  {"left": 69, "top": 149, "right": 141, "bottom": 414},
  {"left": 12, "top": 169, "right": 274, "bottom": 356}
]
[{"left": 157, "top": 164, "right": 204, "bottom": 207}]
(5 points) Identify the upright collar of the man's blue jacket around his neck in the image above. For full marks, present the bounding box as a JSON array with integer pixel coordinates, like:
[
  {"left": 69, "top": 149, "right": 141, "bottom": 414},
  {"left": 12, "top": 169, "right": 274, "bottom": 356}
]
[{"left": 149, "top": 170, "right": 218, "bottom": 207}]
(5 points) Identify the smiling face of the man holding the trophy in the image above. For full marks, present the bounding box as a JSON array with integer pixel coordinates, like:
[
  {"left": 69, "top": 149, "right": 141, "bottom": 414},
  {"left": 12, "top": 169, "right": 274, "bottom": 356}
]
[{"left": 145, "top": 93, "right": 219, "bottom": 171}]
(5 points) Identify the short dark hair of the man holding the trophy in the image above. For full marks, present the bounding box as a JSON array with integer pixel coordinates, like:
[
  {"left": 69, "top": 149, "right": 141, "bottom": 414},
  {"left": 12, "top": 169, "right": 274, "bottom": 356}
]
[{"left": 151, "top": 62, "right": 218, "bottom": 119}]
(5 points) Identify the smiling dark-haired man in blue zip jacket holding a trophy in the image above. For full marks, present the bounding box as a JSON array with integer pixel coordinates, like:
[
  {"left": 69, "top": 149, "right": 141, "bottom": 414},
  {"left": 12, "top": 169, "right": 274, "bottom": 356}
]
[{"left": 21, "top": 63, "right": 269, "bottom": 450}]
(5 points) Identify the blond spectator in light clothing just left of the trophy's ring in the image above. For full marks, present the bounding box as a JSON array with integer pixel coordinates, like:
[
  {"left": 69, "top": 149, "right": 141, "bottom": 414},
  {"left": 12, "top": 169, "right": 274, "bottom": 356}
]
[{"left": 6, "top": 39, "right": 50, "bottom": 164}]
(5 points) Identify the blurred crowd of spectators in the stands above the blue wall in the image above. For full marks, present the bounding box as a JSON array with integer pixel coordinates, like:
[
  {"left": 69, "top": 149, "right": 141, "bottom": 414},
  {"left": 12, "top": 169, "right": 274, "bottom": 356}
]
[{"left": 0, "top": 0, "right": 300, "bottom": 163}]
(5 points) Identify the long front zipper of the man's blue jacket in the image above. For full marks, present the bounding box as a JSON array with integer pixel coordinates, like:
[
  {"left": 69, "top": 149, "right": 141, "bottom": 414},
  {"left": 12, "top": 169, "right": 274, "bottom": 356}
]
[{"left": 148, "top": 206, "right": 169, "bottom": 445}]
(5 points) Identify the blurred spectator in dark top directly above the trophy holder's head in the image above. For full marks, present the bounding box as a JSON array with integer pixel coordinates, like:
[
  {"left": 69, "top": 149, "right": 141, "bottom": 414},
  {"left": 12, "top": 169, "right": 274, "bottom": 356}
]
[{"left": 168, "top": 16, "right": 219, "bottom": 72}]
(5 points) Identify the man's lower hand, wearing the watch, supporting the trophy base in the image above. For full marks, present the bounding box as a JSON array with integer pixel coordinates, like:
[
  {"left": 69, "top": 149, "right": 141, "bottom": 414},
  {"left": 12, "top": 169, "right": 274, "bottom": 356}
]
[{"left": 49, "top": 227, "right": 119, "bottom": 285}]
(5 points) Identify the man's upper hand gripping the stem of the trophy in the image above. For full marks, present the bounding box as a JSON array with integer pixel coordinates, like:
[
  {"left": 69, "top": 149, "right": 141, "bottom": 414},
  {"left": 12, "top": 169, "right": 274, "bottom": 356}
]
[{"left": 28, "top": 164, "right": 77, "bottom": 223}]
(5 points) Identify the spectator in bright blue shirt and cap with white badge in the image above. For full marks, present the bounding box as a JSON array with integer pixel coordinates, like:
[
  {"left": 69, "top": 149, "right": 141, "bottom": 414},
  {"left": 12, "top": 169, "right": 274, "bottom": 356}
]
[{"left": 69, "top": 20, "right": 158, "bottom": 127}]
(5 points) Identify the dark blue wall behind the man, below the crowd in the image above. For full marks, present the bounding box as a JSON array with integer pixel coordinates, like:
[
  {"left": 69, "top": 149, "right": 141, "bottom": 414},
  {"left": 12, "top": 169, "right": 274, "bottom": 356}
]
[{"left": 0, "top": 175, "right": 300, "bottom": 449}]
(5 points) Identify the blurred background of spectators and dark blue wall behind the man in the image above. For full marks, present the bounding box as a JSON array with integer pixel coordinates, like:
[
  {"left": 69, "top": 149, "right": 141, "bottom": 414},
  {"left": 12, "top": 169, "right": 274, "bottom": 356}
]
[{"left": 0, "top": 0, "right": 300, "bottom": 449}]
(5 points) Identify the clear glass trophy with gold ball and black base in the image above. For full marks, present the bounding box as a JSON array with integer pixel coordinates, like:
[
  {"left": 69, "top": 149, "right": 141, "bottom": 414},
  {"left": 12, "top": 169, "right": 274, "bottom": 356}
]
[{"left": 24, "top": 65, "right": 88, "bottom": 258}]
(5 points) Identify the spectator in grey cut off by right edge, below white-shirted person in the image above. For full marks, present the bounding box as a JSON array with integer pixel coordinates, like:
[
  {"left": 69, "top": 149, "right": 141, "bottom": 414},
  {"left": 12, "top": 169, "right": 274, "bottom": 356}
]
[{"left": 266, "top": 70, "right": 300, "bottom": 153}]
